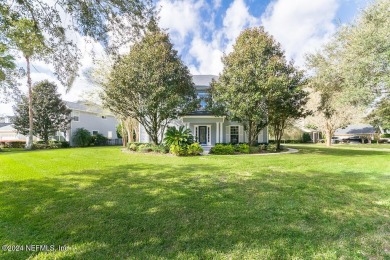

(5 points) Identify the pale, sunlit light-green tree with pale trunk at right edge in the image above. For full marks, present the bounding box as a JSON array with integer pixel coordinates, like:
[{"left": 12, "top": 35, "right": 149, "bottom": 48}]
[{"left": 307, "top": 0, "right": 390, "bottom": 145}]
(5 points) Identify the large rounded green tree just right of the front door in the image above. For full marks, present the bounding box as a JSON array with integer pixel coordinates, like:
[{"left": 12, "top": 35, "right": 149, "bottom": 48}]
[{"left": 211, "top": 27, "right": 305, "bottom": 148}]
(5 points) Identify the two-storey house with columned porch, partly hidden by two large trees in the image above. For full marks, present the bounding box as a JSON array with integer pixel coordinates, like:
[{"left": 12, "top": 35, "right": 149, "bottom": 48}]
[{"left": 139, "top": 75, "right": 268, "bottom": 146}]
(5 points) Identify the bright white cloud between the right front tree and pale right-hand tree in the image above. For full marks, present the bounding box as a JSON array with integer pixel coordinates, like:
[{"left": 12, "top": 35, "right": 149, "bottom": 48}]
[{"left": 261, "top": 0, "right": 339, "bottom": 66}]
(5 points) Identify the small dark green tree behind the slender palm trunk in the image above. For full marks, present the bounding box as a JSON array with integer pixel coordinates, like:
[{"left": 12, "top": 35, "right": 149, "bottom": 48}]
[{"left": 14, "top": 80, "right": 71, "bottom": 144}]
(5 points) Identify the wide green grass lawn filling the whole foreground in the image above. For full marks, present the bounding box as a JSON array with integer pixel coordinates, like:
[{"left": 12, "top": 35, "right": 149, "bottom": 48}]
[{"left": 0, "top": 145, "right": 390, "bottom": 259}]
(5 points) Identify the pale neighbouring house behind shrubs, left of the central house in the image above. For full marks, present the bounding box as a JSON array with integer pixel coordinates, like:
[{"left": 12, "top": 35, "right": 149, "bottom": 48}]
[{"left": 62, "top": 101, "right": 120, "bottom": 146}]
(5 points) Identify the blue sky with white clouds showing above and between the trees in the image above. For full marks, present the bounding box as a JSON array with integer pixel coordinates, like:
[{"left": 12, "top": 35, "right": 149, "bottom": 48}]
[{"left": 0, "top": 0, "right": 369, "bottom": 114}]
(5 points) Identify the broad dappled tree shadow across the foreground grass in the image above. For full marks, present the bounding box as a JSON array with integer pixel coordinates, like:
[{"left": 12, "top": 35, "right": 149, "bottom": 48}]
[{"left": 0, "top": 163, "right": 389, "bottom": 259}]
